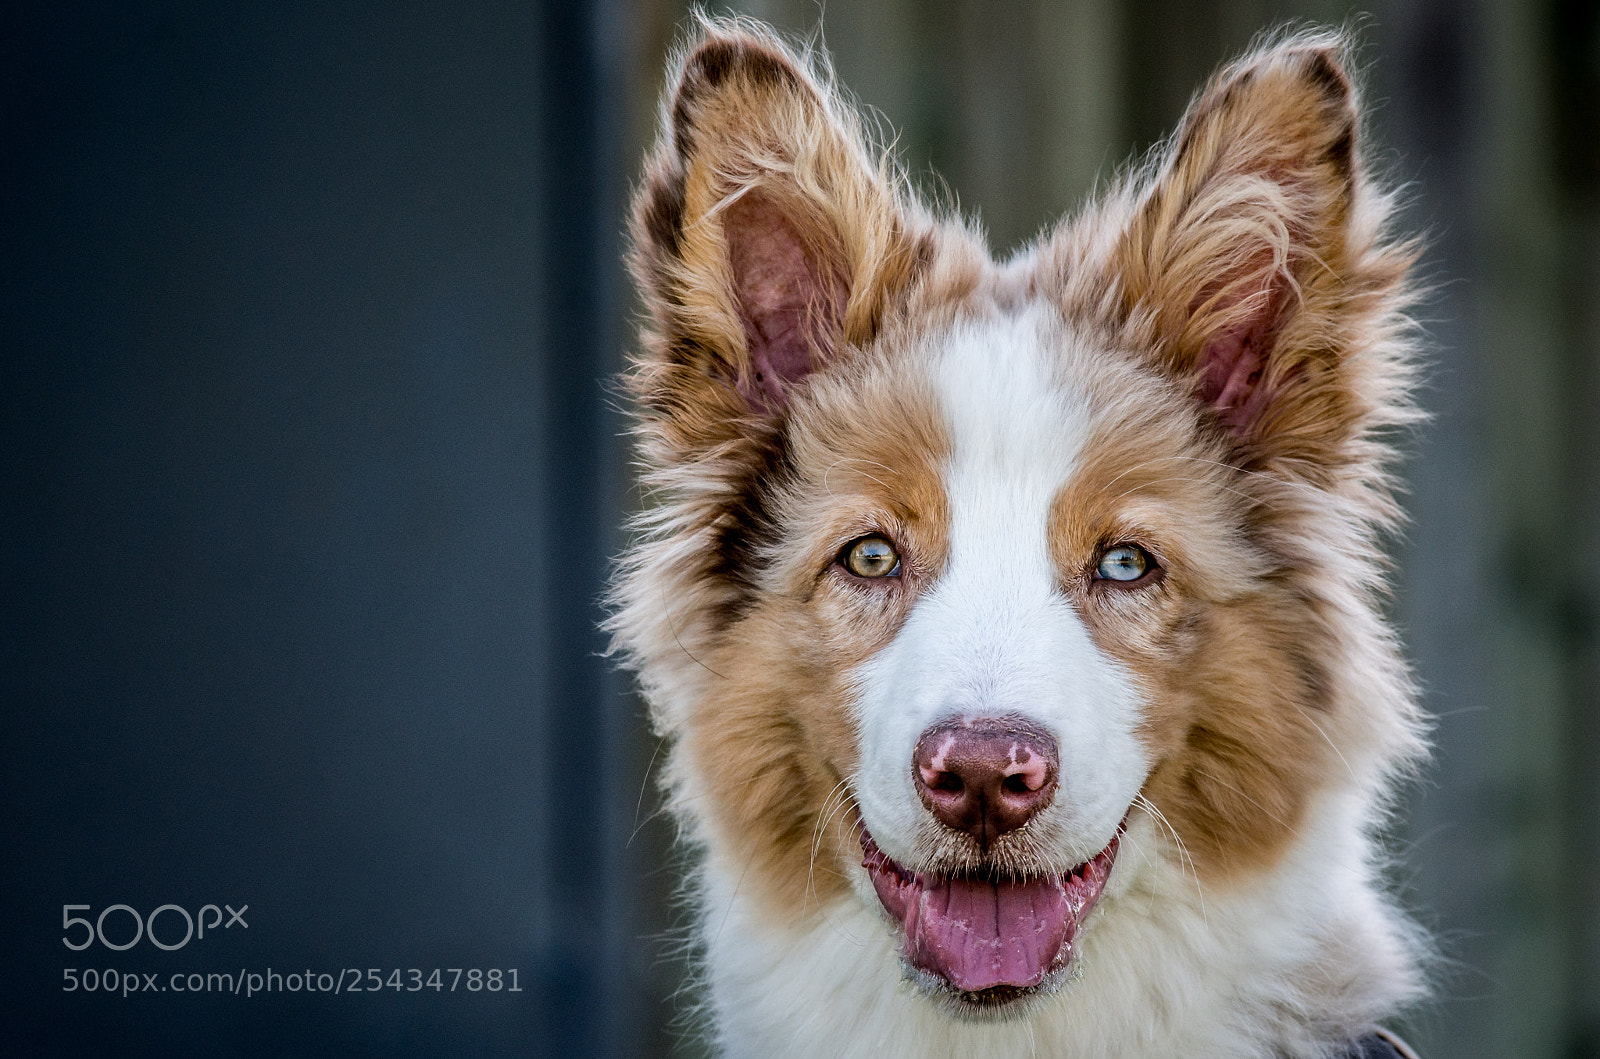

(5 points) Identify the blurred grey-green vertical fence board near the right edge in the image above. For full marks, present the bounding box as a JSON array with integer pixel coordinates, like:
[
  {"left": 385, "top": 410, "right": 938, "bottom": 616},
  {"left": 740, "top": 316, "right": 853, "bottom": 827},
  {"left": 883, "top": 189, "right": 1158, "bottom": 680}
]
[{"left": 1458, "top": 0, "right": 1578, "bottom": 1056}]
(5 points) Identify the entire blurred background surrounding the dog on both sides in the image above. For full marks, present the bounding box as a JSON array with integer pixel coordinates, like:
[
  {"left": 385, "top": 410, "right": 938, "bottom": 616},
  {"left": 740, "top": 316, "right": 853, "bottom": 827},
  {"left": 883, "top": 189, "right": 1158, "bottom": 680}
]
[{"left": 0, "top": 0, "right": 1600, "bottom": 1059}]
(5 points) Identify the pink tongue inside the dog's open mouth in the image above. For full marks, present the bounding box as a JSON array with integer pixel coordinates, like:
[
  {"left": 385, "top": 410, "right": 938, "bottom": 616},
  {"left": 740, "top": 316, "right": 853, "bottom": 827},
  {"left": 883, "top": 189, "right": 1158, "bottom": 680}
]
[{"left": 902, "top": 878, "right": 1077, "bottom": 992}]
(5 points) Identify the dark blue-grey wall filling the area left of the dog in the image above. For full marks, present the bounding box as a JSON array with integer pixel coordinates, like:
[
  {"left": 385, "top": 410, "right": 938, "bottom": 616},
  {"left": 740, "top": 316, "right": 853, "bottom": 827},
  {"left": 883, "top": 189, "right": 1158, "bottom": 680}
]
[{"left": 0, "top": 3, "right": 659, "bottom": 1056}]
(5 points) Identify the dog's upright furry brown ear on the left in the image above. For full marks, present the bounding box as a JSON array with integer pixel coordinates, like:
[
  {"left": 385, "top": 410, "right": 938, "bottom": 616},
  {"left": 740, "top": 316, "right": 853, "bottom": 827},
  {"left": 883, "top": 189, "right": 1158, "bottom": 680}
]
[{"left": 632, "top": 21, "right": 915, "bottom": 444}]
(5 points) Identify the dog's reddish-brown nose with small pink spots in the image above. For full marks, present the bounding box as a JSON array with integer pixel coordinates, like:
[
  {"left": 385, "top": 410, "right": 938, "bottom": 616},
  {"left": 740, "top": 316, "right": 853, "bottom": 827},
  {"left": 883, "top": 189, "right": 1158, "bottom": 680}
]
[{"left": 912, "top": 717, "right": 1061, "bottom": 849}]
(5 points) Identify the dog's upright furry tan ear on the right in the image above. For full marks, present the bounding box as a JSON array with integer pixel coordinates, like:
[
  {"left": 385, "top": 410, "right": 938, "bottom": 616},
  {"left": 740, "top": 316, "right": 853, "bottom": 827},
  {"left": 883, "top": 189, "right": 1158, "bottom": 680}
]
[{"left": 1114, "top": 35, "right": 1413, "bottom": 467}]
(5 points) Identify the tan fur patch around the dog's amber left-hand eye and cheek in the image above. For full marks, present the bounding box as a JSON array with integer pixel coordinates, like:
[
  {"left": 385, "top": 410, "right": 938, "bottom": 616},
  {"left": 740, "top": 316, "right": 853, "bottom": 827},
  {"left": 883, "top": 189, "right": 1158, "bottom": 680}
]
[{"left": 683, "top": 362, "right": 946, "bottom": 917}]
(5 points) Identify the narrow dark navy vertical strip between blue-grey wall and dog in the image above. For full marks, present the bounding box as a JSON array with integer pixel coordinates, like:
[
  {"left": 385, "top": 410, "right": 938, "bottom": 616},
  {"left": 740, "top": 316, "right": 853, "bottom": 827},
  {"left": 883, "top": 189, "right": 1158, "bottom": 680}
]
[{"left": 530, "top": 0, "right": 634, "bottom": 1057}]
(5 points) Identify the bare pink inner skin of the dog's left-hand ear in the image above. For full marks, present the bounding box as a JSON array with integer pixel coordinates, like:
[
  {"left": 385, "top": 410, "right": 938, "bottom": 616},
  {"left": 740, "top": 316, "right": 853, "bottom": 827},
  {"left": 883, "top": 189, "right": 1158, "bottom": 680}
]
[{"left": 722, "top": 192, "right": 845, "bottom": 411}]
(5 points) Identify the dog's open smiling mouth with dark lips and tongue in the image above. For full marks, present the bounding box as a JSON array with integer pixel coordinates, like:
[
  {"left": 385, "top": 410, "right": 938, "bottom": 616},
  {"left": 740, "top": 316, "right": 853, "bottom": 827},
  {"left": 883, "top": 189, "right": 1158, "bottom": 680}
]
[{"left": 861, "top": 827, "right": 1122, "bottom": 1006}]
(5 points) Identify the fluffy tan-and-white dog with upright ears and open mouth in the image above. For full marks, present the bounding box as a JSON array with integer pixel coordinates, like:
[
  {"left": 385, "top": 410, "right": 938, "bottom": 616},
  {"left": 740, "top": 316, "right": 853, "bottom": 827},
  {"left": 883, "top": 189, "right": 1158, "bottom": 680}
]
[{"left": 610, "top": 18, "right": 1429, "bottom": 1059}]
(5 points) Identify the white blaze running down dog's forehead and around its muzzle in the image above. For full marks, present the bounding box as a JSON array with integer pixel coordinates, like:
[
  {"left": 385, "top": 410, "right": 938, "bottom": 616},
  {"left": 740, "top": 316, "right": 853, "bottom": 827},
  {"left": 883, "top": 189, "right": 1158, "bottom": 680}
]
[{"left": 854, "top": 309, "right": 1147, "bottom": 864}]
